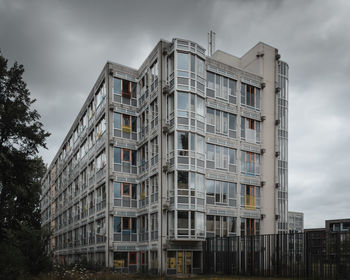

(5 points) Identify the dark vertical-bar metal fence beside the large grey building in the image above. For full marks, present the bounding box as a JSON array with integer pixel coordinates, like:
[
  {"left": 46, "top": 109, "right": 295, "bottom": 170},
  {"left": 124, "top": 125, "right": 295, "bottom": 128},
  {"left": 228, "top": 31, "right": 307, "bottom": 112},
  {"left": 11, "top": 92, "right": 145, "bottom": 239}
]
[{"left": 204, "top": 232, "right": 350, "bottom": 279}]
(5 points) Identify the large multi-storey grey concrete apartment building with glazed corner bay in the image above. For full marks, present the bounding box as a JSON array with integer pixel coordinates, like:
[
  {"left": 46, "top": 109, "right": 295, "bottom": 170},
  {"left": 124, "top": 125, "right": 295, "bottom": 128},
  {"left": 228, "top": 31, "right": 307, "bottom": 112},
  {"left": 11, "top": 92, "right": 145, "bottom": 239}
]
[{"left": 41, "top": 36, "right": 288, "bottom": 274}]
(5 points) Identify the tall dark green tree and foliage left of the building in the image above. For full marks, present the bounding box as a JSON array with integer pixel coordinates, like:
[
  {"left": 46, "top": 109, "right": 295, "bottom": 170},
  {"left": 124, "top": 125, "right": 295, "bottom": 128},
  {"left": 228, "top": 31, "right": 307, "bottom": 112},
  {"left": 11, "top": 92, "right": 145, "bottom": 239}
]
[{"left": 0, "top": 53, "right": 49, "bottom": 279}]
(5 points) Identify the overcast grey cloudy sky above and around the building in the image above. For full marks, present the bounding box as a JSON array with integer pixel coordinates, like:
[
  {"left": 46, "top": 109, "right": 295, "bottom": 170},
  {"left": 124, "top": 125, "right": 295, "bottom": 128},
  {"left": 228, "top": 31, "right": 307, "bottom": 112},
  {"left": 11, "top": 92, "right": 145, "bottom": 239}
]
[{"left": 0, "top": 0, "right": 350, "bottom": 227}]
